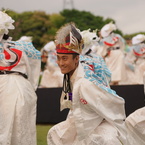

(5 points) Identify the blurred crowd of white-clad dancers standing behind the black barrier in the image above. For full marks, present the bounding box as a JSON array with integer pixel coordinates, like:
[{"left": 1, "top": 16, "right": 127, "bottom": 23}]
[{"left": 40, "top": 22, "right": 145, "bottom": 87}]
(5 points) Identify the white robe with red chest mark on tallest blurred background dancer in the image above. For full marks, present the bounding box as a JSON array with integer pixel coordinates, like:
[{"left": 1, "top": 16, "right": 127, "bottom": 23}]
[{"left": 101, "top": 33, "right": 126, "bottom": 82}]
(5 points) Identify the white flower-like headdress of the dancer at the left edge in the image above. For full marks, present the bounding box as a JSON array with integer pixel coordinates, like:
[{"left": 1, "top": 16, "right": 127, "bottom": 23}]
[{"left": 0, "top": 11, "right": 15, "bottom": 40}]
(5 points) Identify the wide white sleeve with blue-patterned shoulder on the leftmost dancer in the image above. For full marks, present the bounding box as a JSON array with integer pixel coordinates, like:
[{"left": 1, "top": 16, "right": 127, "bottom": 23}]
[{"left": 15, "top": 41, "right": 41, "bottom": 90}]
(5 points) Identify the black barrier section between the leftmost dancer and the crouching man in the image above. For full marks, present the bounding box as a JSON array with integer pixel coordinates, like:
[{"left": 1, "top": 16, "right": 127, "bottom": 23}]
[{"left": 36, "top": 88, "right": 69, "bottom": 124}]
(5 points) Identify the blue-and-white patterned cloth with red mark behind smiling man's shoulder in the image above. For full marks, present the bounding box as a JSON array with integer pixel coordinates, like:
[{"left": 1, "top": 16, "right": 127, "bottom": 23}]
[{"left": 80, "top": 54, "right": 118, "bottom": 96}]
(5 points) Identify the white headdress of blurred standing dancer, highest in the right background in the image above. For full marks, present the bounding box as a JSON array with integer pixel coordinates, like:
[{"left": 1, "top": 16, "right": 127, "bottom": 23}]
[{"left": 101, "top": 22, "right": 116, "bottom": 37}]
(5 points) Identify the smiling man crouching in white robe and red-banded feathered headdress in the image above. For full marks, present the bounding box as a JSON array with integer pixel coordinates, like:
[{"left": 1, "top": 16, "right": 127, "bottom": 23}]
[{"left": 47, "top": 23, "right": 126, "bottom": 145}]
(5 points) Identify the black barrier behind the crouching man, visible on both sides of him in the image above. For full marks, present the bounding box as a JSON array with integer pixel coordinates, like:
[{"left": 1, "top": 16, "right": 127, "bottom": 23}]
[{"left": 36, "top": 85, "right": 145, "bottom": 124}]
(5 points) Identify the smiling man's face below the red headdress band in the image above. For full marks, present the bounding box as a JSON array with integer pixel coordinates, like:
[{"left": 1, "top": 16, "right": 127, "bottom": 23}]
[{"left": 57, "top": 54, "right": 79, "bottom": 74}]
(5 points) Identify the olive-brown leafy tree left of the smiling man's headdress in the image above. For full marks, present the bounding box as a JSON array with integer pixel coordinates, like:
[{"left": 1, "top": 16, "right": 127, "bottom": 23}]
[{"left": 7, "top": 11, "right": 64, "bottom": 50}]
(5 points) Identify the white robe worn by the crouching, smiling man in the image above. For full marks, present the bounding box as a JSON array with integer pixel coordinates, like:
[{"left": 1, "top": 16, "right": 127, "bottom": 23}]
[{"left": 47, "top": 62, "right": 126, "bottom": 145}]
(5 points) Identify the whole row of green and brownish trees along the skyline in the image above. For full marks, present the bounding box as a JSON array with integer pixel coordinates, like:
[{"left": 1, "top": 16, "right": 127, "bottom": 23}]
[{"left": 1, "top": 9, "right": 145, "bottom": 50}]
